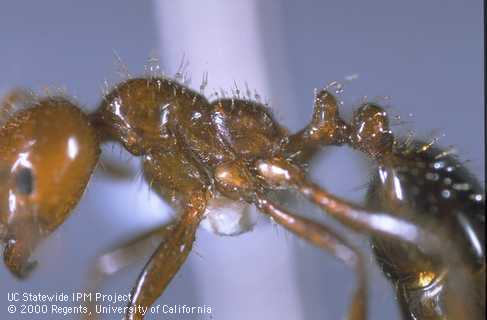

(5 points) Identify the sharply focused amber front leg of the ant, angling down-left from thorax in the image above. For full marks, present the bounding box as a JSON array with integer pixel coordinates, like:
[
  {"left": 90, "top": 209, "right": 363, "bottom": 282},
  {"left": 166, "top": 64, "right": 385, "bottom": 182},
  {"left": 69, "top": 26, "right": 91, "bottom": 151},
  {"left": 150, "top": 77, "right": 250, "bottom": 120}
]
[{"left": 125, "top": 145, "right": 210, "bottom": 320}]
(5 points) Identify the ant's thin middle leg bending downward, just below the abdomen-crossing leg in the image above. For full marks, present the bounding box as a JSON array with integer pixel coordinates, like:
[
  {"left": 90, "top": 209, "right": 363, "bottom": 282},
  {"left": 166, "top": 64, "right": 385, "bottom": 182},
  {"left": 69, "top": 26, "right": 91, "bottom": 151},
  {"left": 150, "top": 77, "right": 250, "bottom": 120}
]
[{"left": 256, "top": 195, "right": 367, "bottom": 320}]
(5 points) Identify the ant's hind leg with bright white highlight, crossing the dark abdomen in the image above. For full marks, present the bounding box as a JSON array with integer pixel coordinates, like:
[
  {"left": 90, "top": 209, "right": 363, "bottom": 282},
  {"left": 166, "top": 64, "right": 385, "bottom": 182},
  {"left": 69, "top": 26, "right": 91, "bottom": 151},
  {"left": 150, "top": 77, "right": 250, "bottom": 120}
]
[{"left": 255, "top": 158, "right": 485, "bottom": 319}]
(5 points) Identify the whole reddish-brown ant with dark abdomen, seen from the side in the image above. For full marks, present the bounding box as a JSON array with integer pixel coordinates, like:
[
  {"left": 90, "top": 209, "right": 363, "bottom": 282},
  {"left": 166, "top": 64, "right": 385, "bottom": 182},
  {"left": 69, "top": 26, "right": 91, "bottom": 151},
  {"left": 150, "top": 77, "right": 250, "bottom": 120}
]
[{"left": 0, "top": 76, "right": 485, "bottom": 320}]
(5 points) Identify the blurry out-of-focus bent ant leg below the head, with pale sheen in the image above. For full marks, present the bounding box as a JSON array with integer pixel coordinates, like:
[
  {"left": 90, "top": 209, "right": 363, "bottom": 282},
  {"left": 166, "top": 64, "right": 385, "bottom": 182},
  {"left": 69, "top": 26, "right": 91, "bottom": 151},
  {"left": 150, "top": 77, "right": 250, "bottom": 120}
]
[{"left": 85, "top": 224, "right": 172, "bottom": 320}]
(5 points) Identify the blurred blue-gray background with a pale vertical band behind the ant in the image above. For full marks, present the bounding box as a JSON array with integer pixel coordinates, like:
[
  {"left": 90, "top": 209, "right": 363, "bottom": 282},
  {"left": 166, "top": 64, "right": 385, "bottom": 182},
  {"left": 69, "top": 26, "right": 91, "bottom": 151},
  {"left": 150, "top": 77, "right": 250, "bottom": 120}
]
[{"left": 0, "top": 0, "right": 485, "bottom": 320}]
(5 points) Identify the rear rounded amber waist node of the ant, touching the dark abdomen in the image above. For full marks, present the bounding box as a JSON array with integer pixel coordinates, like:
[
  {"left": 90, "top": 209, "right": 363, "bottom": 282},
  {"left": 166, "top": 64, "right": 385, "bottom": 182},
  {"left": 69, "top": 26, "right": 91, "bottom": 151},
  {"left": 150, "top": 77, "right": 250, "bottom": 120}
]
[{"left": 350, "top": 103, "right": 394, "bottom": 158}]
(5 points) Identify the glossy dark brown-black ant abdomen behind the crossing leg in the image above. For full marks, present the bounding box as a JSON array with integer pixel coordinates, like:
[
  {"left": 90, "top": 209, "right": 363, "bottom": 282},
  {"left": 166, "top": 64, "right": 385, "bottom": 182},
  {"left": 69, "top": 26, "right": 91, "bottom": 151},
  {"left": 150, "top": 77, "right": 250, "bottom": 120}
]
[{"left": 367, "top": 142, "right": 485, "bottom": 319}]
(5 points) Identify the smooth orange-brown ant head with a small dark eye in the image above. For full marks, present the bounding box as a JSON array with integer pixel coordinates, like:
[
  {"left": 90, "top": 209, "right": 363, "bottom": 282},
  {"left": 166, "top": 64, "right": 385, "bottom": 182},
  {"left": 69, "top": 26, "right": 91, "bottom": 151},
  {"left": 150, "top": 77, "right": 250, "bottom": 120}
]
[{"left": 0, "top": 98, "right": 99, "bottom": 277}]
